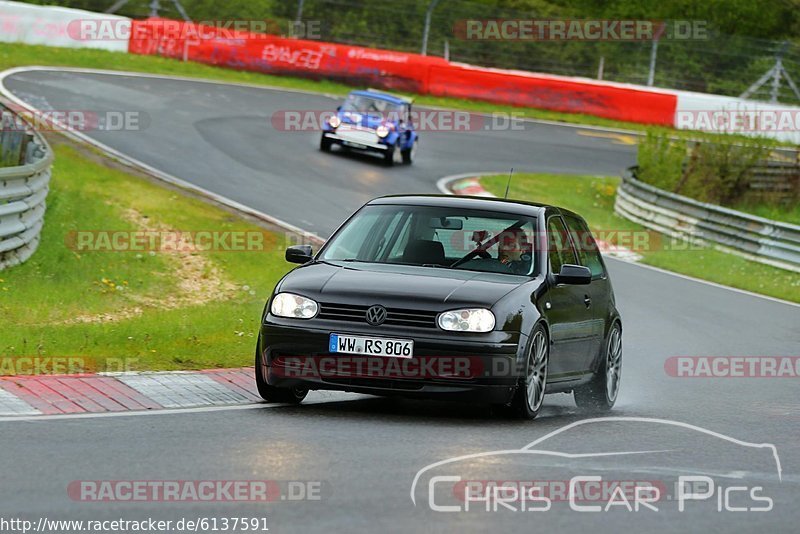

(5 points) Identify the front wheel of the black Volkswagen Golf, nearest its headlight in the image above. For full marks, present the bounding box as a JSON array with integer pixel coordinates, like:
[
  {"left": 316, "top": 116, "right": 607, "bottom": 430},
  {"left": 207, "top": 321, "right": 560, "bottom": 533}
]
[{"left": 506, "top": 324, "right": 550, "bottom": 419}]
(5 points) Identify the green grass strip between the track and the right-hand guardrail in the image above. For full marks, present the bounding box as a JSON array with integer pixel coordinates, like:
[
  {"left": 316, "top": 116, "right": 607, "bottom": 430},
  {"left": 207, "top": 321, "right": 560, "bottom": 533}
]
[{"left": 481, "top": 174, "right": 800, "bottom": 302}]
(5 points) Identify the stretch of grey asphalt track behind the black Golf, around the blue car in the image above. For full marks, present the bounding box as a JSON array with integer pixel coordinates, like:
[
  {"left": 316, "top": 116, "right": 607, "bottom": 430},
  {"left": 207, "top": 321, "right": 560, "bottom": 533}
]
[{"left": 5, "top": 72, "right": 635, "bottom": 236}]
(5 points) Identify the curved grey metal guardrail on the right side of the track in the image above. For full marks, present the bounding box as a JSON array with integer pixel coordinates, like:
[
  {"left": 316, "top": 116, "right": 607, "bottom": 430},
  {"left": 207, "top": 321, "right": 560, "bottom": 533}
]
[{"left": 614, "top": 167, "right": 800, "bottom": 272}]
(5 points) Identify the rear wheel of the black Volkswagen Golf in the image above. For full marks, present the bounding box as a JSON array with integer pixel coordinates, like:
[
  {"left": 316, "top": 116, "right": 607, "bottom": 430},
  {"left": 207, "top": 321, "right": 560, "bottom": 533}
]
[{"left": 575, "top": 323, "right": 622, "bottom": 412}]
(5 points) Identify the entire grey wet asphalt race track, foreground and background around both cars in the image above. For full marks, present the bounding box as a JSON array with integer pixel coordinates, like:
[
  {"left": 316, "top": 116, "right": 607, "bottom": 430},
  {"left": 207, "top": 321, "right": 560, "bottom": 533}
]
[{"left": 0, "top": 71, "right": 800, "bottom": 532}]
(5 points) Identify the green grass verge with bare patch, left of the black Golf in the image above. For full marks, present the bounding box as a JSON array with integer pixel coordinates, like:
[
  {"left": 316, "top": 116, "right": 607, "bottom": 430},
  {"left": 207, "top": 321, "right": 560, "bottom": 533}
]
[{"left": 0, "top": 141, "right": 288, "bottom": 375}]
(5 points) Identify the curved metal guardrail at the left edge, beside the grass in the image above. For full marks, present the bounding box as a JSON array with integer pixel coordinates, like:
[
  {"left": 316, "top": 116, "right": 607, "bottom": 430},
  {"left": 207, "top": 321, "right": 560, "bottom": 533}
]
[{"left": 0, "top": 107, "right": 53, "bottom": 271}]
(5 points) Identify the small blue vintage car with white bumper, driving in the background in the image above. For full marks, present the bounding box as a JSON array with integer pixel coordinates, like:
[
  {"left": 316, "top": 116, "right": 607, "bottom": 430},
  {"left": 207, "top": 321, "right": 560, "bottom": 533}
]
[{"left": 319, "top": 90, "right": 419, "bottom": 165}]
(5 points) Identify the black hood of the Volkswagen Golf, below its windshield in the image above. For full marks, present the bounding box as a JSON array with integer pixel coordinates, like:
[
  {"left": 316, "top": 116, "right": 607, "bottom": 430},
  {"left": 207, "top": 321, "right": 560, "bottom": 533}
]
[{"left": 277, "top": 262, "right": 529, "bottom": 311}]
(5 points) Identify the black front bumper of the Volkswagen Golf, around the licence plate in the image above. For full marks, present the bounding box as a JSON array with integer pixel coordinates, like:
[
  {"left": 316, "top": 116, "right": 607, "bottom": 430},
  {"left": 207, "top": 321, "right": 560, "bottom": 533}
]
[{"left": 256, "top": 319, "right": 527, "bottom": 403}]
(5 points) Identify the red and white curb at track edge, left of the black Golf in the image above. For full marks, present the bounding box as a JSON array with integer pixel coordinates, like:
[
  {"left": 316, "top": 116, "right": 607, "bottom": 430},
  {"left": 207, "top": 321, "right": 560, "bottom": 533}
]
[{"left": 0, "top": 367, "right": 261, "bottom": 416}]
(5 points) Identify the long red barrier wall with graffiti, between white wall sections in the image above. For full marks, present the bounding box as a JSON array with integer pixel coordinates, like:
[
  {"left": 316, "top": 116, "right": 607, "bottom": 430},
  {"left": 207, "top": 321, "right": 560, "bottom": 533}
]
[{"left": 129, "top": 19, "right": 677, "bottom": 126}]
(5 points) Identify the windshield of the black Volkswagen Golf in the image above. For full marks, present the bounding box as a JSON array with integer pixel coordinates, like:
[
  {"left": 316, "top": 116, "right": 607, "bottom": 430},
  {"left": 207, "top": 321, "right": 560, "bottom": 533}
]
[{"left": 319, "top": 205, "right": 538, "bottom": 275}]
